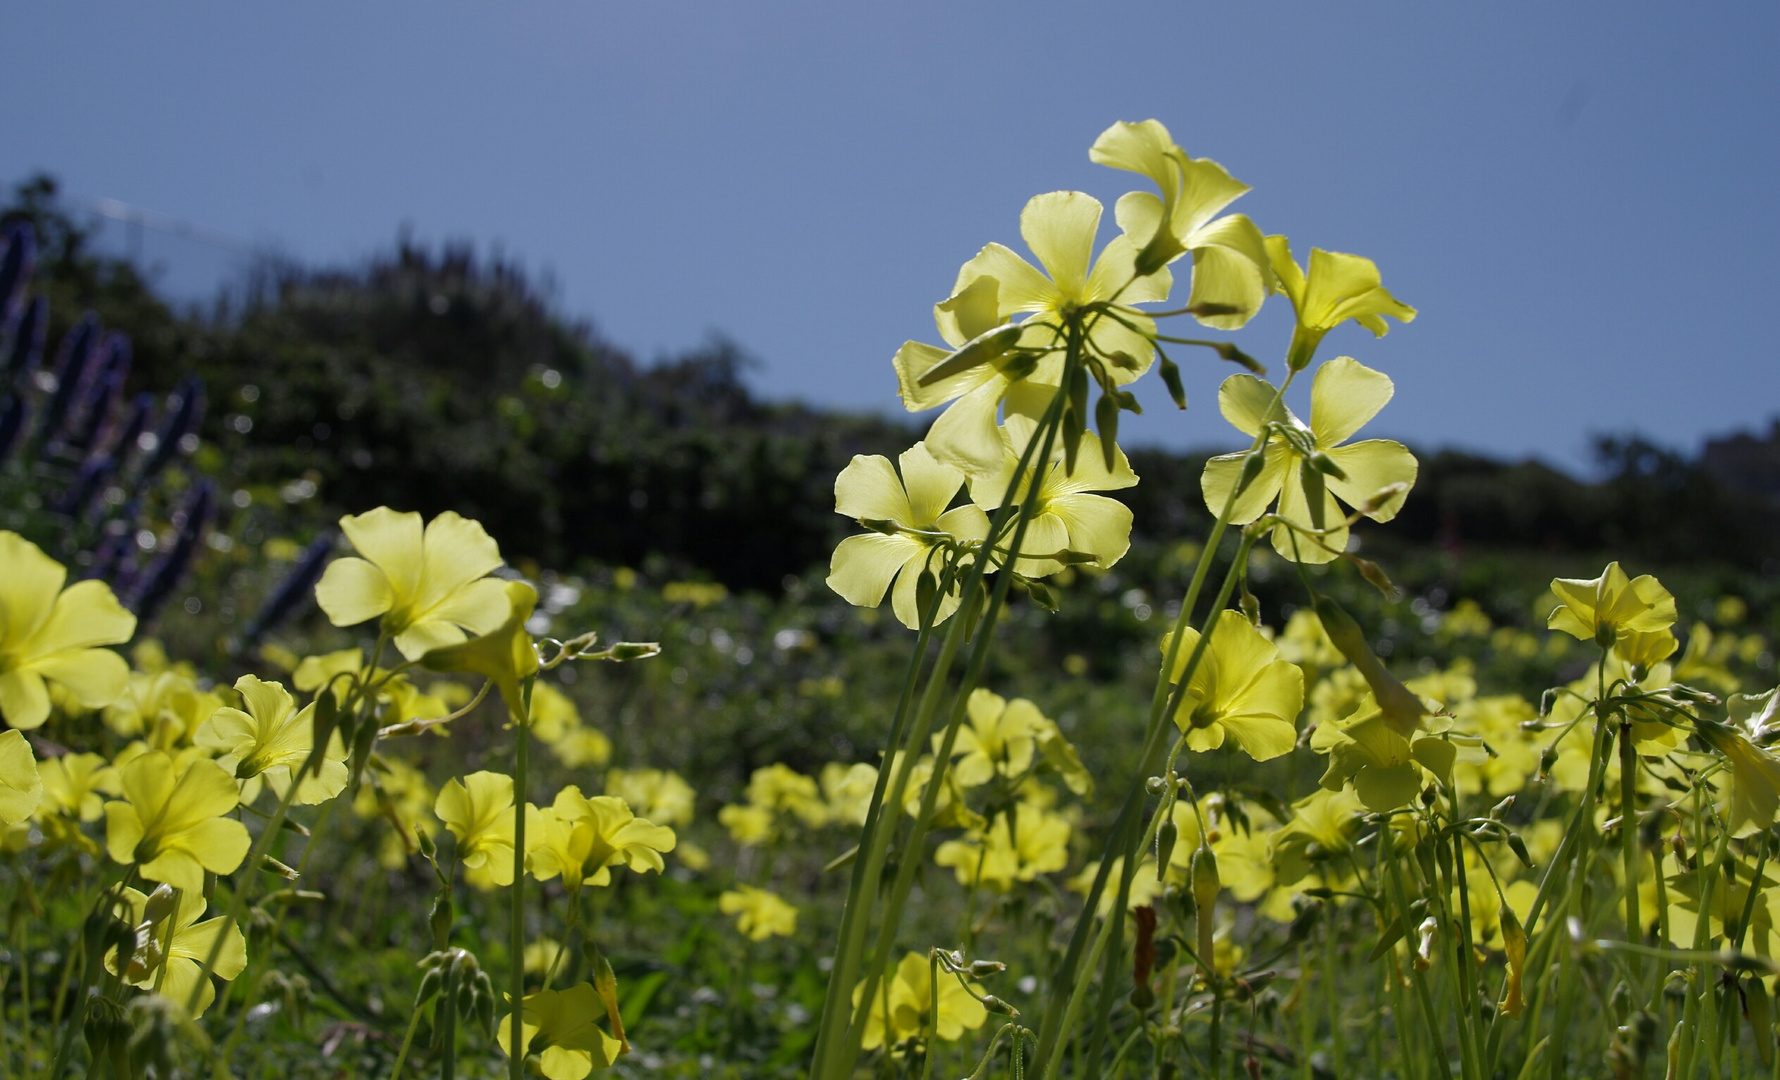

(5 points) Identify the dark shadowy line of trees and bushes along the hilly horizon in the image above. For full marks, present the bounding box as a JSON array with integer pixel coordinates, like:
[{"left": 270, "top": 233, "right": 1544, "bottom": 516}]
[{"left": 4, "top": 178, "right": 1780, "bottom": 587}]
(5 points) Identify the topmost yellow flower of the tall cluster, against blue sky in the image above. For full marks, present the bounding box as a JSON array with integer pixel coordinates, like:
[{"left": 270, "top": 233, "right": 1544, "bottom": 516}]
[{"left": 1088, "top": 119, "right": 1274, "bottom": 329}]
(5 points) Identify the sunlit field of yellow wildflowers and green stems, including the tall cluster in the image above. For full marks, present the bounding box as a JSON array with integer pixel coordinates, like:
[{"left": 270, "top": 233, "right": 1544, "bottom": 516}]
[{"left": 0, "top": 121, "right": 1780, "bottom": 1080}]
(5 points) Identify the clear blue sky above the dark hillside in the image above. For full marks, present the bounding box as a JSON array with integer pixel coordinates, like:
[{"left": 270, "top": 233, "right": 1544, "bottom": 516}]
[{"left": 0, "top": 0, "right": 1780, "bottom": 464}]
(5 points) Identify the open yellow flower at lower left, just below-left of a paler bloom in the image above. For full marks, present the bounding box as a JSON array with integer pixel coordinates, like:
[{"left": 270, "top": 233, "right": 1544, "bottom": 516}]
[{"left": 105, "top": 751, "right": 249, "bottom": 893}]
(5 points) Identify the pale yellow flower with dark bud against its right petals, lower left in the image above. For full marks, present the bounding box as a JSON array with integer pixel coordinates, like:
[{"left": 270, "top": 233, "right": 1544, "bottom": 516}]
[{"left": 196, "top": 674, "right": 347, "bottom": 806}]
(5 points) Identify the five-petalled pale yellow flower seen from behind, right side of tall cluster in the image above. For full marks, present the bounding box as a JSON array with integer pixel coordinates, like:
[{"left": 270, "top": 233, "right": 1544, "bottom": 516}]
[{"left": 1200, "top": 356, "right": 1419, "bottom": 562}]
